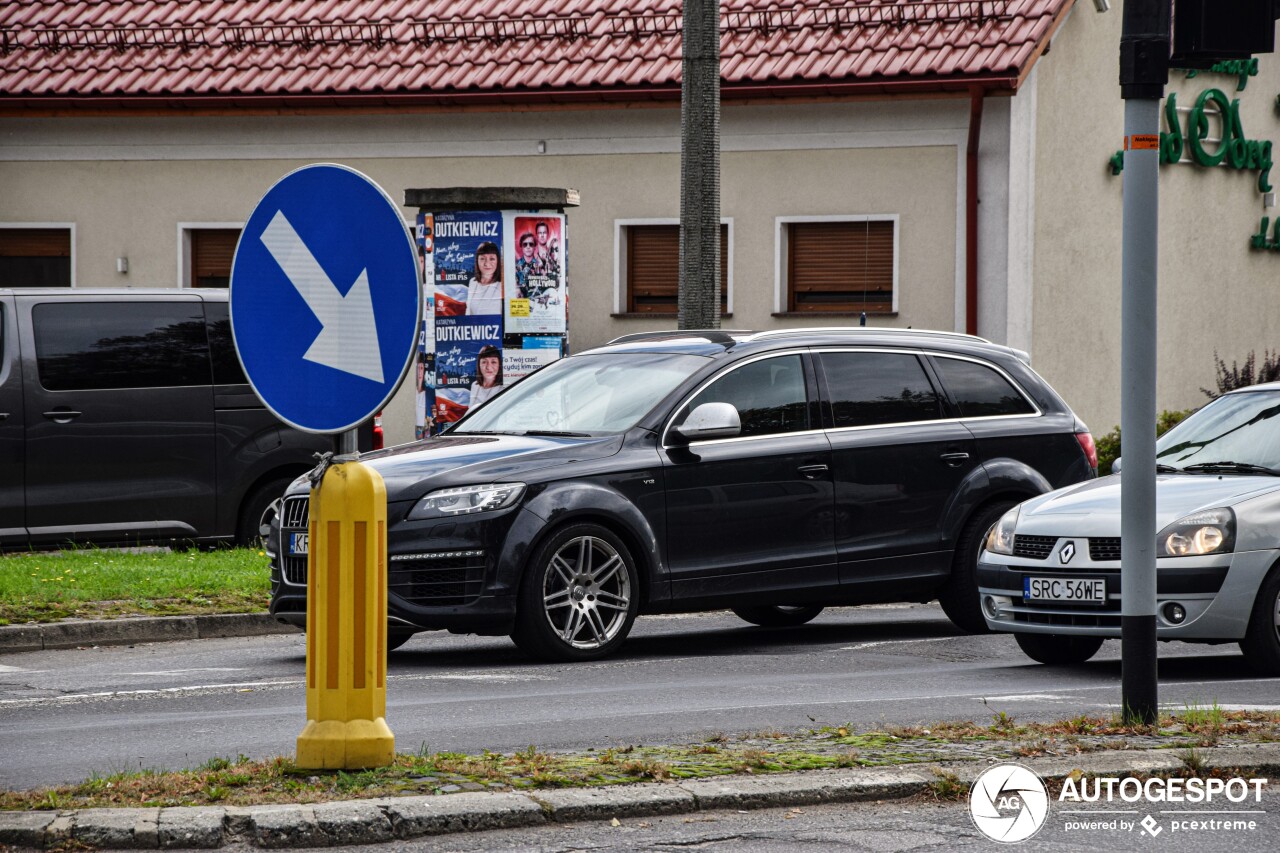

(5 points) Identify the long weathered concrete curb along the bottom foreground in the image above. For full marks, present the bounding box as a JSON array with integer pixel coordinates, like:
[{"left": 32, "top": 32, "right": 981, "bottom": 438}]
[{"left": 0, "top": 743, "right": 1280, "bottom": 849}]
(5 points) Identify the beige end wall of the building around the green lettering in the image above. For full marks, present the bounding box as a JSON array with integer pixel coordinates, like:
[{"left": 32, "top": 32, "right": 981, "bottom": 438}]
[{"left": 1032, "top": 4, "right": 1280, "bottom": 434}]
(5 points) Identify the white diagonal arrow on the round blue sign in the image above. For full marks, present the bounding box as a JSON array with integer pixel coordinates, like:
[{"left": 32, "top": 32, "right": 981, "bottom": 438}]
[{"left": 262, "top": 210, "right": 383, "bottom": 383}]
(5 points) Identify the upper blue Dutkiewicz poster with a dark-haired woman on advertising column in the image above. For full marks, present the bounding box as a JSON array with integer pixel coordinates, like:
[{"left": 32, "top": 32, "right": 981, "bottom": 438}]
[{"left": 431, "top": 210, "right": 504, "bottom": 321}]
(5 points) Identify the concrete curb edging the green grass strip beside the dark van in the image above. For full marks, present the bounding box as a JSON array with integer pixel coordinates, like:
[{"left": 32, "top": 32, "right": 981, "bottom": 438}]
[{"left": 0, "top": 613, "right": 300, "bottom": 654}]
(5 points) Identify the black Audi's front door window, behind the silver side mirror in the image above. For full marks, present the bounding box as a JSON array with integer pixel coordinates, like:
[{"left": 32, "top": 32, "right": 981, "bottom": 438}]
[{"left": 681, "top": 355, "right": 809, "bottom": 435}]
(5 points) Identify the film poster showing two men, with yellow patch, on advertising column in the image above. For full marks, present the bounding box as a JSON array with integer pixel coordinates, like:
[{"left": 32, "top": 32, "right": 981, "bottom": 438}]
[{"left": 506, "top": 213, "right": 566, "bottom": 334}]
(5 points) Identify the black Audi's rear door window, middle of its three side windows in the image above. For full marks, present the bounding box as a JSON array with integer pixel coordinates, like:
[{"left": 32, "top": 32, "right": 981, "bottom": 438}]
[{"left": 822, "top": 351, "right": 942, "bottom": 428}]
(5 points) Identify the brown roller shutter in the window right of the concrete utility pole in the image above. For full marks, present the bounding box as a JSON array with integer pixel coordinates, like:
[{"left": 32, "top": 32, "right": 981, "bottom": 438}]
[{"left": 787, "top": 220, "right": 893, "bottom": 314}]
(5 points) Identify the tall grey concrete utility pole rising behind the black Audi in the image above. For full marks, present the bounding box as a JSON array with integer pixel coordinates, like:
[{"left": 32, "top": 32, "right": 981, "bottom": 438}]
[{"left": 677, "top": 0, "right": 721, "bottom": 329}]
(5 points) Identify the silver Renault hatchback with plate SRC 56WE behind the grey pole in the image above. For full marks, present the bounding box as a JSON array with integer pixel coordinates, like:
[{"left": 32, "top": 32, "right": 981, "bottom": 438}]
[{"left": 977, "top": 383, "right": 1280, "bottom": 675}]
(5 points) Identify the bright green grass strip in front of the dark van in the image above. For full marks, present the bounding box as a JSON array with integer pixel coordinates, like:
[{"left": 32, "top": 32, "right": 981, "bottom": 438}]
[{"left": 0, "top": 548, "right": 270, "bottom": 625}]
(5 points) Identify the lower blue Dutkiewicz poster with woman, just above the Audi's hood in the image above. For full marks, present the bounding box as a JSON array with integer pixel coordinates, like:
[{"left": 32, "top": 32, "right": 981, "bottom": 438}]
[{"left": 435, "top": 316, "right": 503, "bottom": 423}]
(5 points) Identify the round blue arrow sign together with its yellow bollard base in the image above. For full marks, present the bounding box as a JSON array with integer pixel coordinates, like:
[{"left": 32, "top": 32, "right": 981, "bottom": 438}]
[{"left": 230, "top": 164, "right": 422, "bottom": 770}]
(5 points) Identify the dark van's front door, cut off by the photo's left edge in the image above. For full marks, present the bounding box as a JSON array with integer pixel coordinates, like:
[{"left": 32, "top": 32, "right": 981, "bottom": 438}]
[{"left": 0, "top": 293, "right": 27, "bottom": 546}]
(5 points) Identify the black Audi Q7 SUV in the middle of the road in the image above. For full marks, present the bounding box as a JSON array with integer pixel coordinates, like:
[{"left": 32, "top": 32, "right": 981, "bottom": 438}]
[{"left": 270, "top": 328, "right": 1097, "bottom": 661}]
